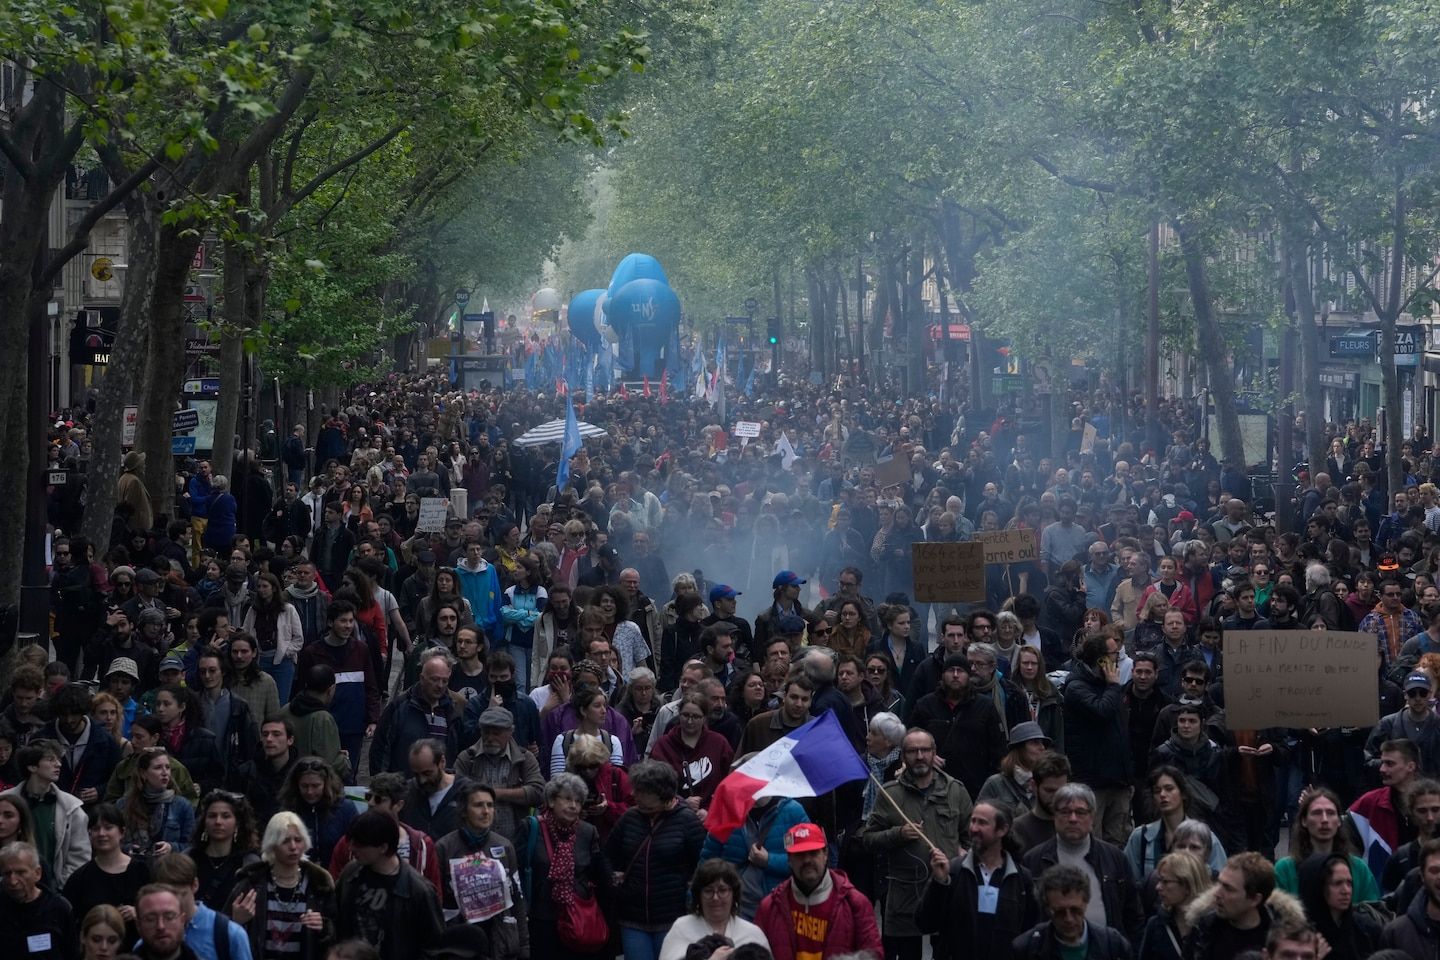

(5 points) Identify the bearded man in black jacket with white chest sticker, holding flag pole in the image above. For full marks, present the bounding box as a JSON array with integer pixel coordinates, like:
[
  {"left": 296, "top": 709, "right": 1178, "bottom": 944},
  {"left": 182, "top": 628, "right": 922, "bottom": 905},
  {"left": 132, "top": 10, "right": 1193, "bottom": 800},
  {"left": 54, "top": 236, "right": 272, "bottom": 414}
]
[{"left": 920, "top": 800, "right": 1036, "bottom": 960}]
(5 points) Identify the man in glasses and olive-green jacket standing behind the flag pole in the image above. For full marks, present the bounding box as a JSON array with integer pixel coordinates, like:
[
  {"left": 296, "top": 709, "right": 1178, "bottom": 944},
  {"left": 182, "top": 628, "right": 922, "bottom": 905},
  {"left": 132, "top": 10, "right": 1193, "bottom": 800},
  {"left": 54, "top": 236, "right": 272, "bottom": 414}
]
[{"left": 861, "top": 730, "right": 967, "bottom": 960}]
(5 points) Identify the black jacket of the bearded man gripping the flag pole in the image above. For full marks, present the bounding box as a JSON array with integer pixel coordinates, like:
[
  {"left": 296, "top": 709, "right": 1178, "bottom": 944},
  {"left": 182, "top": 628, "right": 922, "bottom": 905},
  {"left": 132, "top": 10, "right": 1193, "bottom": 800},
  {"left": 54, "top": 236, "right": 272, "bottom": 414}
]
[{"left": 917, "top": 853, "right": 1040, "bottom": 960}]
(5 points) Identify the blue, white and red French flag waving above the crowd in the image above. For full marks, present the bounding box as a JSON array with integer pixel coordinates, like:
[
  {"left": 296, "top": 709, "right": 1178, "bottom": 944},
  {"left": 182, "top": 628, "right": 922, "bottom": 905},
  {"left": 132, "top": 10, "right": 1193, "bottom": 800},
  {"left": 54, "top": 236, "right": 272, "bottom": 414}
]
[{"left": 706, "top": 710, "right": 870, "bottom": 843}]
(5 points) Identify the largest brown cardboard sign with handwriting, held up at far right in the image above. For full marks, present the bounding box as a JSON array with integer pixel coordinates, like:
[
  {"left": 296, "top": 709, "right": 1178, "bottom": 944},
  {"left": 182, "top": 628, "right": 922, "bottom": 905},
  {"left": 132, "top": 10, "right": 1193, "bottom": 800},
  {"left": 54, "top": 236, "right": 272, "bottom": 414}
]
[{"left": 1225, "top": 630, "right": 1380, "bottom": 730}]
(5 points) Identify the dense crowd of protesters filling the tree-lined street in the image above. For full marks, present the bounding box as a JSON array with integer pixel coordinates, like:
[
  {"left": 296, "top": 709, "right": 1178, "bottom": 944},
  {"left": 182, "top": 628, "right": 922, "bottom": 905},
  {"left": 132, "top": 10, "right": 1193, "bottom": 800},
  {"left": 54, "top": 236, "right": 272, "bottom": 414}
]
[{"left": 22, "top": 376, "right": 1440, "bottom": 960}]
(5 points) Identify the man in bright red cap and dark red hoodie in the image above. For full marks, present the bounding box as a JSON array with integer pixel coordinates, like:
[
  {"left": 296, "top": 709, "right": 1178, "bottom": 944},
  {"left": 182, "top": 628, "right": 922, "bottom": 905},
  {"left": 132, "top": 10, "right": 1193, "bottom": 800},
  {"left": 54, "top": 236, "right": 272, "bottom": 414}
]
[{"left": 755, "top": 823, "right": 884, "bottom": 960}]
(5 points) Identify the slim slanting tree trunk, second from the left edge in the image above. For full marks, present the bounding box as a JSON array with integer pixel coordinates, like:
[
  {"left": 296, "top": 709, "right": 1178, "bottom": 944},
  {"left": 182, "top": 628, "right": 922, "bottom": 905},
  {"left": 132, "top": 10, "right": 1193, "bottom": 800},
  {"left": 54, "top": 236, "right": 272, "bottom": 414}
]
[{"left": 81, "top": 193, "right": 157, "bottom": 557}]
